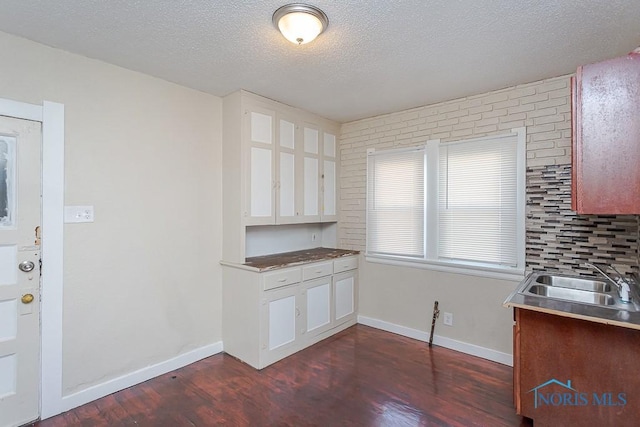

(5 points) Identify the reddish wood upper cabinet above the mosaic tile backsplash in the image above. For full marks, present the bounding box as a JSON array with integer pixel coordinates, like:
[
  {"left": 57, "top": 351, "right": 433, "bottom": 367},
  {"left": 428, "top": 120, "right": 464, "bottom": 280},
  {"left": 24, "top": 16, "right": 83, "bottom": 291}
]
[{"left": 571, "top": 49, "right": 640, "bottom": 215}]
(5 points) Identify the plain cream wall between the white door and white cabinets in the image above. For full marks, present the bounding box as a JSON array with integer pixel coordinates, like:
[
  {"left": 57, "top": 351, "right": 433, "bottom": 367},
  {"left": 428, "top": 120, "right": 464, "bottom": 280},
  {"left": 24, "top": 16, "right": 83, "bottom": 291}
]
[{"left": 0, "top": 33, "right": 222, "bottom": 395}]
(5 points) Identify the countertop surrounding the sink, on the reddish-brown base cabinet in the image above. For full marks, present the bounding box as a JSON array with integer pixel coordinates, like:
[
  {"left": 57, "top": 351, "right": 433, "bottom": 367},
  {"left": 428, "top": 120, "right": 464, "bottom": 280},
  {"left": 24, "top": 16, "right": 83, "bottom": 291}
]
[{"left": 503, "top": 273, "right": 640, "bottom": 330}]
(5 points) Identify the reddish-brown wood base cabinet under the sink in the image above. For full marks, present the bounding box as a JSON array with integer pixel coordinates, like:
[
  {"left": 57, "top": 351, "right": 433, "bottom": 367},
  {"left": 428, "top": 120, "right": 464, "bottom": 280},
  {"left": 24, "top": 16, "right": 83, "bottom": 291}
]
[{"left": 513, "top": 308, "right": 640, "bottom": 427}]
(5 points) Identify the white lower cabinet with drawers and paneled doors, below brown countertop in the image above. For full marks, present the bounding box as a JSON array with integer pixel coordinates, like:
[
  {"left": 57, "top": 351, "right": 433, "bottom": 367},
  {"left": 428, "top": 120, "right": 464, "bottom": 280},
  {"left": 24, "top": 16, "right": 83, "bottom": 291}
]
[{"left": 222, "top": 256, "right": 358, "bottom": 369}]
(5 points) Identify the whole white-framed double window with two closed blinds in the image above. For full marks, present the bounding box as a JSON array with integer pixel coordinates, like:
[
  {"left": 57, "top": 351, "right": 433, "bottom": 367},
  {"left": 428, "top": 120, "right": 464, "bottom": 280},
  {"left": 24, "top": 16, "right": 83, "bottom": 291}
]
[{"left": 367, "top": 128, "right": 526, "bottom": 272}]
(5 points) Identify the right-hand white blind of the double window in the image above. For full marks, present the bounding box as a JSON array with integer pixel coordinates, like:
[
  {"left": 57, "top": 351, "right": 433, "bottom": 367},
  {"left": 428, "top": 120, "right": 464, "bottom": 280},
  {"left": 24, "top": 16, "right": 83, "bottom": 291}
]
[{"left": 438, "top": 136, "right": 518, "bottom": 267}]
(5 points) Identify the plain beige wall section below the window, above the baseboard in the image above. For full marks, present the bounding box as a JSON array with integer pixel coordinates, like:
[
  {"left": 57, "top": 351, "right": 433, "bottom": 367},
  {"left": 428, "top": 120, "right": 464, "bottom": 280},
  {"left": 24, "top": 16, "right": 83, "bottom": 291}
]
[{"left": 359, "top": 257, "right": 517, "bottom": 354}]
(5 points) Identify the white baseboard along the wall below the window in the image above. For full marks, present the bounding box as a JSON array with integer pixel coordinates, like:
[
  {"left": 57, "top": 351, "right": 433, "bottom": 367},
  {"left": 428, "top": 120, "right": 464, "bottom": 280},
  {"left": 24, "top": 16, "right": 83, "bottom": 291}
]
[{"left": 358, "top": 316, "right": 513, "bottom": 366}]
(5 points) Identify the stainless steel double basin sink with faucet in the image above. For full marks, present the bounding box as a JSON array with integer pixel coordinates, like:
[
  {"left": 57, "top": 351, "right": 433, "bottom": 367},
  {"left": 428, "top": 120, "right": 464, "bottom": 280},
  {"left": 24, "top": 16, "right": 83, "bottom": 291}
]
[{"left": 518, "top": 273, "right": 640, "bottom": 312}]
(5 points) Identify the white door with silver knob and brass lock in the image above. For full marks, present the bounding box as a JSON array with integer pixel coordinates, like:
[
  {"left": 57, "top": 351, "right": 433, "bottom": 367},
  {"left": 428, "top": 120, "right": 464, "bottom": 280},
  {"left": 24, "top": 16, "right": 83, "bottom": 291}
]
[{"left": 0, "top": 117, "right": 41, "bottom": 427}]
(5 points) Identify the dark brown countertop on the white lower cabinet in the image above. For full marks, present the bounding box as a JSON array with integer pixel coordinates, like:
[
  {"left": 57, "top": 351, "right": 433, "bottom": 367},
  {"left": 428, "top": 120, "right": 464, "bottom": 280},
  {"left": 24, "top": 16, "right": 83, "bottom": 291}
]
[{"left": 222, "top": 248, "right": 360, "bottom": 271}]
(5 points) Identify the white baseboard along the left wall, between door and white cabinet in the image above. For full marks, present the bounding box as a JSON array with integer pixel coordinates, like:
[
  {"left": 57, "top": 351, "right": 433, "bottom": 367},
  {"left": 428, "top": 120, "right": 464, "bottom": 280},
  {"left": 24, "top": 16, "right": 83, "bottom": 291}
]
[{"left": 58, "top": 341, "right": 223, "bottom": 416}]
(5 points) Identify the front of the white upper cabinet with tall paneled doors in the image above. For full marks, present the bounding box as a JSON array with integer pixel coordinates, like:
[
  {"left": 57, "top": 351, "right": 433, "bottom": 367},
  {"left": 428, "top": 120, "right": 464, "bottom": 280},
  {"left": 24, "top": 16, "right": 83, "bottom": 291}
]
[{"left": 244, "top": 107, "right": 337, "bottom": 225}]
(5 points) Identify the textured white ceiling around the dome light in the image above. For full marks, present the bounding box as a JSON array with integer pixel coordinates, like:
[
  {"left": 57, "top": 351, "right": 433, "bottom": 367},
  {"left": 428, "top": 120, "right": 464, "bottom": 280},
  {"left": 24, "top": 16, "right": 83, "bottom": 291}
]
[{"left": 0, "top": 0, "right": 640, "bottom": 122}]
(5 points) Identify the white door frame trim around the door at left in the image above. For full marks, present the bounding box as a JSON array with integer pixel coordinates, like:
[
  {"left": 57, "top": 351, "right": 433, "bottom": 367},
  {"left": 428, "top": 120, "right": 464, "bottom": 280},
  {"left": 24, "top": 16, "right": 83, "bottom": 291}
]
[{"left": 0, "top": 98, "right": 64, "bottom": 419}]
